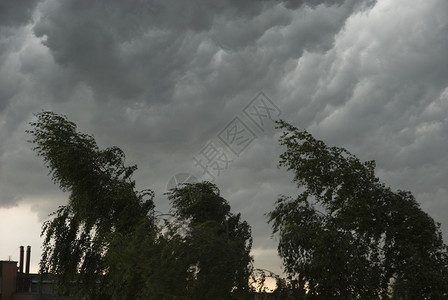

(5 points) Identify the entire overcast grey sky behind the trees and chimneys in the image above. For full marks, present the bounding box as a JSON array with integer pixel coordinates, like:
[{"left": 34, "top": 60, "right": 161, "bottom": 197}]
[{"left": 0, "top": 0, "right": 448, "bottom": 273}]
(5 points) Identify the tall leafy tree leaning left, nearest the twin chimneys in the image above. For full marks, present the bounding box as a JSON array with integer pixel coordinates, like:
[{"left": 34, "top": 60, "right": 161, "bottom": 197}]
[{"left": 28, "top": 112, "right": 156, "bottom": 299}]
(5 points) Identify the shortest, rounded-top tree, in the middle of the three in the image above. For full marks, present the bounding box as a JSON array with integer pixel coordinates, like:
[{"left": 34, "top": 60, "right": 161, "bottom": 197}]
[{"left": 168, "top": 182, "right": 252, "bottom": 299}]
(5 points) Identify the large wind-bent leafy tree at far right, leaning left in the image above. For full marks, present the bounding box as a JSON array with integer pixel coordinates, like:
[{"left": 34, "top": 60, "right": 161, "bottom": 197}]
[{"left": 268, "top": 121, "right": 448, "bottom": 299}]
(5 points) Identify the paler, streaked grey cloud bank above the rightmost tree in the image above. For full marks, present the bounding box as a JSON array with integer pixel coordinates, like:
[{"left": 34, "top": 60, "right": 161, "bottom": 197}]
[{"left": 282, "top": 1, "right": 448, "bottom": 237}]
